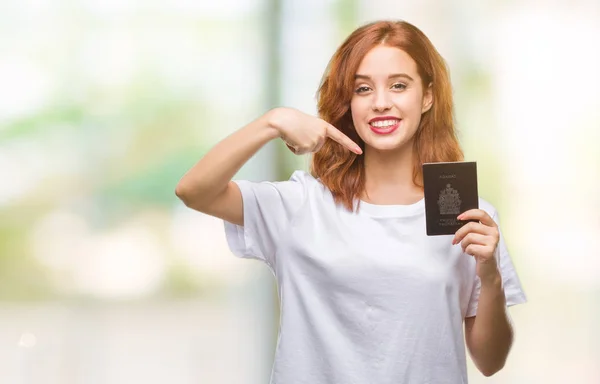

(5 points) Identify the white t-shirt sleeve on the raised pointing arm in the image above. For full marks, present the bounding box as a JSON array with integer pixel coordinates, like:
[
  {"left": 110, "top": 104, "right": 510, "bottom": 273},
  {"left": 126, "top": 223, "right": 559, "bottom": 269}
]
[{"left": 224, "top": 171, "right": 307, "bottom": 271}]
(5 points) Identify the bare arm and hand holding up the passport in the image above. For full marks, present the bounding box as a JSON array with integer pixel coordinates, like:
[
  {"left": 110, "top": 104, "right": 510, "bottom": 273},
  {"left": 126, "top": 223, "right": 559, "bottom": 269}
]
[{"left": 452, "top": 209, "right": 513, "bottom": 376}]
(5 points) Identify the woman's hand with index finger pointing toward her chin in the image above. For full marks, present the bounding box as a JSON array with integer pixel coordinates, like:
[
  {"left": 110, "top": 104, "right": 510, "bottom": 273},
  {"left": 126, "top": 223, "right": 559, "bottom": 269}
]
[{"left": 269, "top": 107, "right": 362, "bottom": 155}]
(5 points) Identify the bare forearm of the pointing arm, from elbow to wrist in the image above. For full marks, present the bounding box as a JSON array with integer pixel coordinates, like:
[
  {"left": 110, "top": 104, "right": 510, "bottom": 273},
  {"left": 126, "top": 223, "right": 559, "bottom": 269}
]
[{"left": 175, "top": 112, "right": 279, "bottom": 205}]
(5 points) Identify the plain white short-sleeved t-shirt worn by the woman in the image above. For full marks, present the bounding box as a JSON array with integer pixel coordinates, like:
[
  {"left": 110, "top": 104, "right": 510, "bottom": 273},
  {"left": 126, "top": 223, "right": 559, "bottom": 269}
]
[{"left": 225, "top": 171, "right": 526, "bottom": 384}]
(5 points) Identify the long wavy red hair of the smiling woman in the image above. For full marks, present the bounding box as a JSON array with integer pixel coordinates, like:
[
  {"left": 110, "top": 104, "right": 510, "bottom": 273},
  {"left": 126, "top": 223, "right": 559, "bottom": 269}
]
[{"left": 310, "top": 20, "right": 463, "bottom": 210}]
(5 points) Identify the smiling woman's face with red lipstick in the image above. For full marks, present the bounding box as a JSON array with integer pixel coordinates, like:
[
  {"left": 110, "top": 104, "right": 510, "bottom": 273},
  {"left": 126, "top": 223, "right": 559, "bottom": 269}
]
[{"left": 350, "top": 45, "right": 432, "bottom": 151}]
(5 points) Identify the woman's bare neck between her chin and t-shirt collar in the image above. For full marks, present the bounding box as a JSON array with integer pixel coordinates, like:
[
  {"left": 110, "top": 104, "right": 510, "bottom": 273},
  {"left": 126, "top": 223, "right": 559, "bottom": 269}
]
[{"left": 363, "top": 143, "right": 423, "bottom": 204}]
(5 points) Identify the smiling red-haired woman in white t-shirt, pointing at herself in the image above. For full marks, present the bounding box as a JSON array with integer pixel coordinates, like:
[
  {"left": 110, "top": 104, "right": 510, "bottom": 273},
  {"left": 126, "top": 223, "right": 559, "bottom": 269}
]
[{"left": 176, "top": 21, "right": 526, "bottom": 384}]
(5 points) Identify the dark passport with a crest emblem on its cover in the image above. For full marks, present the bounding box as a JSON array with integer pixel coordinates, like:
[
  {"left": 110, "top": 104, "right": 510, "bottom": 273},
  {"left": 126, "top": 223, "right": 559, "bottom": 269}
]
[{"left": 423, "top": 161, "right": 479, "bottom": 236}]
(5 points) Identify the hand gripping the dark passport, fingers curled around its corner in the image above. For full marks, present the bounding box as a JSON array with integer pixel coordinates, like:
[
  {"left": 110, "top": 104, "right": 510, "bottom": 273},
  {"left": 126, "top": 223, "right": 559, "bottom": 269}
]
[{"left": 452, "top": 209, "right": 500, "bottom": 283}]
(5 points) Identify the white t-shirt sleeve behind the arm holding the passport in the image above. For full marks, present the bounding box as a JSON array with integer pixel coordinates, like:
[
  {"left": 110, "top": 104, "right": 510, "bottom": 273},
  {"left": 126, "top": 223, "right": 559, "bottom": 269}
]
[{"left": 465, "top": 210, "right": 527, "bottom": 317}]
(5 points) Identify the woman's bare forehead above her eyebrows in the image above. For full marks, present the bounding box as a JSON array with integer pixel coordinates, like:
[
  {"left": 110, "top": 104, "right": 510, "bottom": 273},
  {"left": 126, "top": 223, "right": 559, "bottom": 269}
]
[{"left": 356, "top": 45, "right": 419, "bottom": 79}]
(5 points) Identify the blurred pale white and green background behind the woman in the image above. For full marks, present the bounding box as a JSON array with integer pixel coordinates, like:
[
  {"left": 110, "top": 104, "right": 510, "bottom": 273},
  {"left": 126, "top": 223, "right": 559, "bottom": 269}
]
[{"left": 0, "top": 0, "right": 600, "bottom": 384}]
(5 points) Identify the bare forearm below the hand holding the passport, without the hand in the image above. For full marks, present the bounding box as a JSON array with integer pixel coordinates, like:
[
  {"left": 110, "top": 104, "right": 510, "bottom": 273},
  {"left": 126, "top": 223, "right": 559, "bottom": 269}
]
[{"left": 469, "top": 274, "right": 513, "bottom": 376}]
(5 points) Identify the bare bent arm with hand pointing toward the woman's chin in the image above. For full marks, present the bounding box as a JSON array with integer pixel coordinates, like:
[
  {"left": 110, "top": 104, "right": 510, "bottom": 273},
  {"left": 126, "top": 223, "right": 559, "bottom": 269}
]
[{"left": 175, "top": 108, "right": 362, "bottom": 225}]
